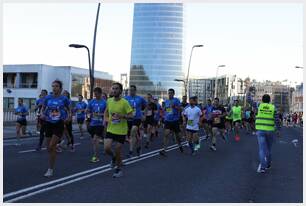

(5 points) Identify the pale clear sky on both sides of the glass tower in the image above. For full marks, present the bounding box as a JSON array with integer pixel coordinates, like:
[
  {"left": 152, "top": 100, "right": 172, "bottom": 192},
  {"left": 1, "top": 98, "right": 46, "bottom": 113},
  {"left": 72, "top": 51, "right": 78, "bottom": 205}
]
[{"left": 3, "top": 3, "right": 303, "bottom": 82}]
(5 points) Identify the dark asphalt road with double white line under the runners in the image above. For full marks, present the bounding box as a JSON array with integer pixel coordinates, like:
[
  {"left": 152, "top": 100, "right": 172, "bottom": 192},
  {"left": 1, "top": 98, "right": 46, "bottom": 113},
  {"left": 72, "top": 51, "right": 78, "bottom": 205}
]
[{"left": 3, "top": 125, "right": 303, "bottom": 203}]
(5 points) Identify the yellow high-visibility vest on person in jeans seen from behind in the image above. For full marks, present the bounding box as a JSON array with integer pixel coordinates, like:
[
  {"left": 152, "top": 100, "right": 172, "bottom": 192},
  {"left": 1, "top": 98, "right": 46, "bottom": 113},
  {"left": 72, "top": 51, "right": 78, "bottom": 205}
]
[{"left": 255, "top": 103, "right": 275, "bottom": 131}]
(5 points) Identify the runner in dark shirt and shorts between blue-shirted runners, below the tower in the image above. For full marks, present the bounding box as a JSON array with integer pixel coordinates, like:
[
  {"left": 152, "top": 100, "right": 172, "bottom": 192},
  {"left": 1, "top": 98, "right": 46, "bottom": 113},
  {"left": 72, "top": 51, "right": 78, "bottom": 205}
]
[{"left": 143, "top": 93, "right": 157, "bottom": 149}]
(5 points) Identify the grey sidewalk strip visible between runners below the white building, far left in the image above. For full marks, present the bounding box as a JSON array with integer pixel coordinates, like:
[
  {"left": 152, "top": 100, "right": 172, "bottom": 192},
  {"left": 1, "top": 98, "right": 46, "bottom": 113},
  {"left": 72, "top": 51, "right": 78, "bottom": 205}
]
[{"left": 3, "top": 123, "right": 81, "bottom": 139}]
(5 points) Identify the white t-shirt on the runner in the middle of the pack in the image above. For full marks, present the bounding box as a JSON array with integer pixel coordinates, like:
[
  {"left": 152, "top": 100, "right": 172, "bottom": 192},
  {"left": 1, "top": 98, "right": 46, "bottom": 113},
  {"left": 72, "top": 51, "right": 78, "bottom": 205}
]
[{"left": 183, "top": 106, "right": 202, "bottom": 131}]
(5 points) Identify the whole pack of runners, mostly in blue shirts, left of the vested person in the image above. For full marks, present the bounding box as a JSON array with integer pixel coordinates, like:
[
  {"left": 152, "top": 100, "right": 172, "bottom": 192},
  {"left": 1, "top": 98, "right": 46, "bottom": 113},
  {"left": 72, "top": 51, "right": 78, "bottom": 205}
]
[{"left": 16, "top": 80, "right": 284, "bottom": 177}]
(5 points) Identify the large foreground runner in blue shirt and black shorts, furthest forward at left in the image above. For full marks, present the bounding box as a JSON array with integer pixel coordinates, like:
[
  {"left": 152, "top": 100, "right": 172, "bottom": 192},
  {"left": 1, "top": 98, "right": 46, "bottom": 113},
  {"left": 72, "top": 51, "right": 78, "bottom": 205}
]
[{"left": 42, "top": 80, "right": 71, "bottom": 177}]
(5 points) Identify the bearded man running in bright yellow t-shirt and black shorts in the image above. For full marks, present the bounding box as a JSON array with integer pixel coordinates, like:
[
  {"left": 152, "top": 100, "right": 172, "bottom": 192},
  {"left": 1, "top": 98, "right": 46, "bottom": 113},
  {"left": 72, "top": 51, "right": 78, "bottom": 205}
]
[{"left": 104, "top": 82, "right": 133, "bottom": 178}]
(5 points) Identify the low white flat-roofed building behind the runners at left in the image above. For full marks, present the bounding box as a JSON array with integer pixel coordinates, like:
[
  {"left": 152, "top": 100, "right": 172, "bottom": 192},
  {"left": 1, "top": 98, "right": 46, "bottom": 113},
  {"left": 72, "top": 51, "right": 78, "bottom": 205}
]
[{"left": 3, "top": 64, "right": 113, "bottom": 111}]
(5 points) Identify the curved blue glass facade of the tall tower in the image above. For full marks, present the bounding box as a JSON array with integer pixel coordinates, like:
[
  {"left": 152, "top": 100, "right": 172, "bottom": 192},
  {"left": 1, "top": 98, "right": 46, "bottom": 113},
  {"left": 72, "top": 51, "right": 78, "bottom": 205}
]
[{"left": 130, "top": 3, "right": 184, "bottom": 98}]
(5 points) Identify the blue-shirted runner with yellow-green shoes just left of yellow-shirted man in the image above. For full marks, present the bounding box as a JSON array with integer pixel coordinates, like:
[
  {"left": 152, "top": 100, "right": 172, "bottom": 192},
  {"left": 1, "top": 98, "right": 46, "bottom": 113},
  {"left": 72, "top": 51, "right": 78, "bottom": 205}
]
[{"left": 86, "top": 87, "right": 106, "bottom": 163}]
